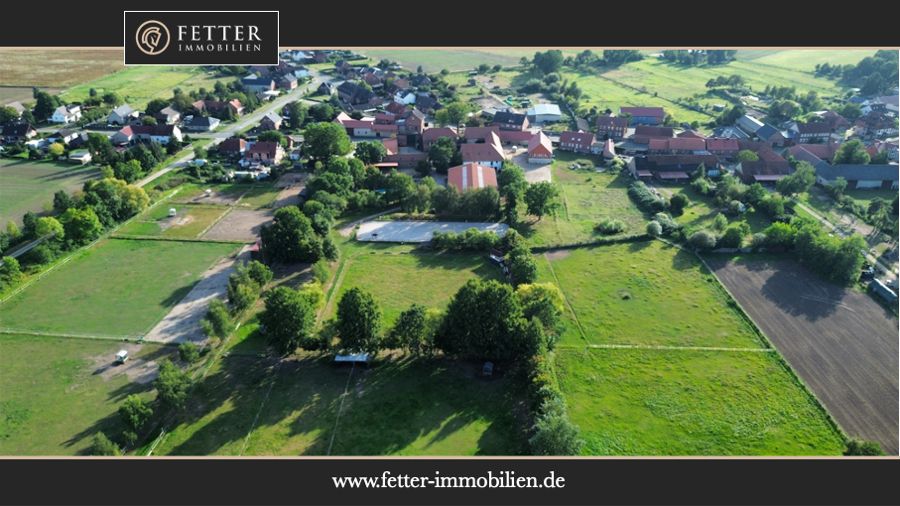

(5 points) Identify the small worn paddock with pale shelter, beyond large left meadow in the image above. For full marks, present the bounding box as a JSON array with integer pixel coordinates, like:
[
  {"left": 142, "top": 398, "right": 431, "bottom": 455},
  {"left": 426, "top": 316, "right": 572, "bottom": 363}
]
[{"left": 116, "top": 203, "right": 228, "bottom": 239}]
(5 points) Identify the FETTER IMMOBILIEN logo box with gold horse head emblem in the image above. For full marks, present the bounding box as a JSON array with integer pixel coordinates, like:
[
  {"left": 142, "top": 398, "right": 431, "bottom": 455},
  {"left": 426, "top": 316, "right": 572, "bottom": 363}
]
[{"left": 124, "top": 11, "right": 279, "bottom": 66}]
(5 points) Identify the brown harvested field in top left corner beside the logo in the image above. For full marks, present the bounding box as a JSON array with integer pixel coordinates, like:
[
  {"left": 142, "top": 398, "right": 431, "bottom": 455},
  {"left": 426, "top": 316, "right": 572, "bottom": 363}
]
[{"left": 0, "top": 47, "right": 125, "bottom": 88}]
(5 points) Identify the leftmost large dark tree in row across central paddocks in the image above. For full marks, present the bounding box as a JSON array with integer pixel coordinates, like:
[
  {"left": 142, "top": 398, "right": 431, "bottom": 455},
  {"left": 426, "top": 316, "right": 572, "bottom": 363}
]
[{"left": 259, "top": 286, "right": 321, "bottom": 355}]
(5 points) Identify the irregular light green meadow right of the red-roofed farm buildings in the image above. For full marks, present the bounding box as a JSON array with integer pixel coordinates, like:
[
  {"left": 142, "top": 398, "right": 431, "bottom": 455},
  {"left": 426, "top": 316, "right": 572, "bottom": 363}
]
[{"left": 518, "top": 155, "right": 646, "bottom": 246}]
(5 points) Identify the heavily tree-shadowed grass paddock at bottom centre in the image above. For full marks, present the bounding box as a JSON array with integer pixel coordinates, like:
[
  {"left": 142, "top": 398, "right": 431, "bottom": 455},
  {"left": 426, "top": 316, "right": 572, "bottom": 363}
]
[{"left": 155, "top": 348, "right": 522, "bottom": 455}]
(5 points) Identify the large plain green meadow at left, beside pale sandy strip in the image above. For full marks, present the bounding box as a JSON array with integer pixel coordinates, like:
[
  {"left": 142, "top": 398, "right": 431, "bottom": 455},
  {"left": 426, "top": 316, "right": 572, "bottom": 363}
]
[{"left": 0, "top": 239, "right": 237, "bottom": 336}]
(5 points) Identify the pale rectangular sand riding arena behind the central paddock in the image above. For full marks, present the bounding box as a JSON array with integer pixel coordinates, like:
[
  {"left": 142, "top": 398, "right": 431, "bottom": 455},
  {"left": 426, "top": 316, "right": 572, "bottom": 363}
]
[{"left": 356, "top": 221, "right": 509, "bottom": 242}]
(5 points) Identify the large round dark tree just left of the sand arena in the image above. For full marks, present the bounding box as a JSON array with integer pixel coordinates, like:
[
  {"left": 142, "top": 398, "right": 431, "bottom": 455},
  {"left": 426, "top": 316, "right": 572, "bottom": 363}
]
[{"left": 260, "top": 206, "right": 322, "bottom": 263}]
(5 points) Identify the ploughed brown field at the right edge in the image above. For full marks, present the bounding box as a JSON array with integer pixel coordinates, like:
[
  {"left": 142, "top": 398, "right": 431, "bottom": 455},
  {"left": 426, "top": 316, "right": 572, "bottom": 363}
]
[{"left": 707, "top": 256, "right": 898, "bottom": 455}]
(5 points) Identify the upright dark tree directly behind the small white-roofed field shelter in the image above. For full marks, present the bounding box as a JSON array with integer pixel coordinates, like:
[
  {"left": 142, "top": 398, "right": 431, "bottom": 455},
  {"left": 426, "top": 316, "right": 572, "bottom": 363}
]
[{"left": 337, "top": 287, "right": 381, "bottom": 353}]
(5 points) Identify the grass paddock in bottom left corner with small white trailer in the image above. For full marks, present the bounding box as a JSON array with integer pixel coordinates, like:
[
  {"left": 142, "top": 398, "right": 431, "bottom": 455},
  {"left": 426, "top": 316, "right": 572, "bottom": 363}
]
[{"left": 0, "top": 334, "right": 171, "bottom": 455}]
